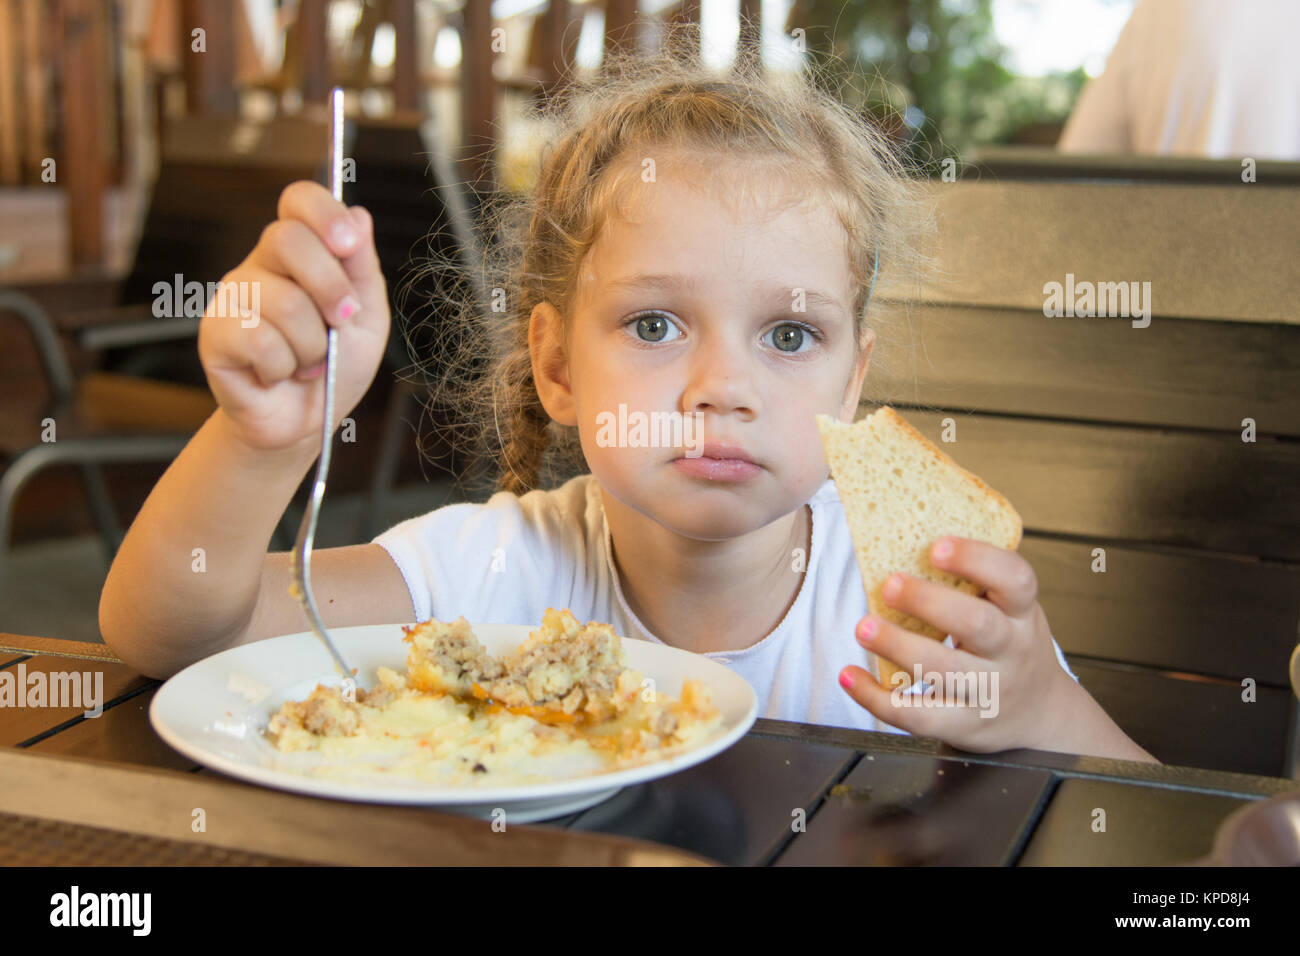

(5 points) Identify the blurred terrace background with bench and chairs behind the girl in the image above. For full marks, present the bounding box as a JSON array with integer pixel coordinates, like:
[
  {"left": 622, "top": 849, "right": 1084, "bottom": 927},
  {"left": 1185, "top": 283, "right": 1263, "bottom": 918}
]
[{"left": 0, "top": 0, "right": 1300, "bottom": 774}]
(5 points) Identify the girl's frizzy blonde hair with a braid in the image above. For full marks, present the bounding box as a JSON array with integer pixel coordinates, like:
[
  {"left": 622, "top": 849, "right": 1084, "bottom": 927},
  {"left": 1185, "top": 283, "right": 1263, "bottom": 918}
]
[{"left": 402, "top": 25, "right": 930, "bottom": 494}]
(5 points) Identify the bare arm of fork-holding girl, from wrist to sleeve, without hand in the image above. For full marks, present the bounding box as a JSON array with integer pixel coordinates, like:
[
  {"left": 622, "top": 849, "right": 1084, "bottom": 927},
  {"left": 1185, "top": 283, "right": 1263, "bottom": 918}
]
[{"left": 99, "top": 408, "right": 415, "bottom": 678}]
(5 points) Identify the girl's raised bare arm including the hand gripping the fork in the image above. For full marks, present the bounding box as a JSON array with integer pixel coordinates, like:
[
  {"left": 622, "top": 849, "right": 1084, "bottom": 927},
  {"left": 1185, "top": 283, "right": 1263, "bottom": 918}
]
[{"left": 99, "top": 182, "right": 412, "bottom": 676}]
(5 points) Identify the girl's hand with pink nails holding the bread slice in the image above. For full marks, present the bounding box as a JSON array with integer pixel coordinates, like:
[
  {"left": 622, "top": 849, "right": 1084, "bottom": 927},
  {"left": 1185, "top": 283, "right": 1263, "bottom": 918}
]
[{"left": 840, "top": 537, "right": 1079, "bottom": 753}]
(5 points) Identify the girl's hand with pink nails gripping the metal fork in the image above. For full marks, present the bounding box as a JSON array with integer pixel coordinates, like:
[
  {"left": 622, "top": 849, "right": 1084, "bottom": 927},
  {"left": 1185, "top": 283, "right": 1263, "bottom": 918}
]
[{"left": 199, "top": 181, "right": 389, "bottom": 450}]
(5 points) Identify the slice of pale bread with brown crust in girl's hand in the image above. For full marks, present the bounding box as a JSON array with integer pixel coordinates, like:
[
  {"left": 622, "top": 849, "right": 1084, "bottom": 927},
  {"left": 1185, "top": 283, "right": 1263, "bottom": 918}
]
[{"left": 816, "top": 406, "right": 1022, "bottom": 688}]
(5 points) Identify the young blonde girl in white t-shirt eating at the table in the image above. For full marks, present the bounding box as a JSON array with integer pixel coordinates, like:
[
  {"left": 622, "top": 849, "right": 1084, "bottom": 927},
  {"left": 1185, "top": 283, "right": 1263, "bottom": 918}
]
[{"left": 100, "top": 41, "right": 1153, "bottom": 760}]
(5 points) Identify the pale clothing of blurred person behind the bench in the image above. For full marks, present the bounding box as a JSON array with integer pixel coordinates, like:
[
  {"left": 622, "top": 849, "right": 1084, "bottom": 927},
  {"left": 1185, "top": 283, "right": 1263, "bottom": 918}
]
[{"left": 1057, "top": 0, "right": 1300, "bottom": 160}]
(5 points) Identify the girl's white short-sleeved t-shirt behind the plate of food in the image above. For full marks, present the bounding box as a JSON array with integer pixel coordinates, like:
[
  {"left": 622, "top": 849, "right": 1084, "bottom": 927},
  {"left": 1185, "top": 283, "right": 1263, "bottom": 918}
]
[{"left": 374, "top": 473, "right": 1078, "bottom": 734}]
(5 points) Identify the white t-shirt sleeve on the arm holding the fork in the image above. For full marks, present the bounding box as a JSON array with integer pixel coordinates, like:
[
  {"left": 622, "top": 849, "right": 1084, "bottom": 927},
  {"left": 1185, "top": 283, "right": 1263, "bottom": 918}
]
[{"left": 373, "top": 492, "right": 575, "bottom": 624}]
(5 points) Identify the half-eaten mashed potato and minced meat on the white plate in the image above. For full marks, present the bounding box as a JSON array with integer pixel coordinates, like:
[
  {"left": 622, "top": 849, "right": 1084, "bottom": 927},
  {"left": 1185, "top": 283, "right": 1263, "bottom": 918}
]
[{"left": 267, "top": 607, "right": 722, "bottom": 786}]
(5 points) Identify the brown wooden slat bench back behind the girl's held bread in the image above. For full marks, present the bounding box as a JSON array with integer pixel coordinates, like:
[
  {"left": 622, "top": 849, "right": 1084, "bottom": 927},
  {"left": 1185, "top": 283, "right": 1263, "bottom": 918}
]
[{"left": 861, "top": 182, "right": 1300, "bottom": 777}]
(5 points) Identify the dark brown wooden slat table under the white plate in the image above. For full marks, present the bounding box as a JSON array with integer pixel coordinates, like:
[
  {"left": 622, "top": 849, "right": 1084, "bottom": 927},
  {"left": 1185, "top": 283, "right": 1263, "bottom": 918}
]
[{"left": 0, "top": 633, "right": 1300, "bottom": 866}]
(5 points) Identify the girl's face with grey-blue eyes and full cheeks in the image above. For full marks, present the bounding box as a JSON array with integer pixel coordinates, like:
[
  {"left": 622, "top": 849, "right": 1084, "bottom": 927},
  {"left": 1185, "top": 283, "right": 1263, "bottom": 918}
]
[{"left": 533, "top": 163, "right": 875, "bottom": 540}]
